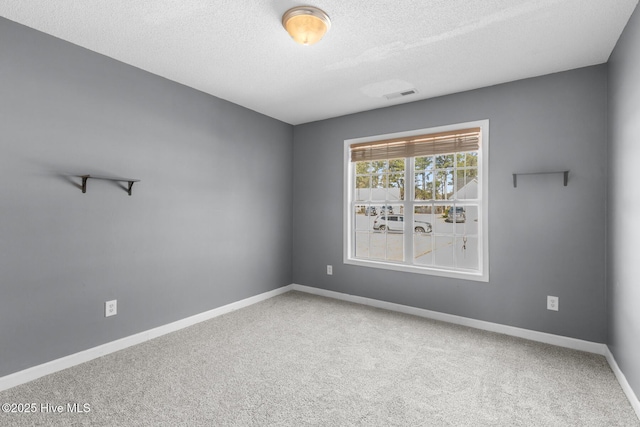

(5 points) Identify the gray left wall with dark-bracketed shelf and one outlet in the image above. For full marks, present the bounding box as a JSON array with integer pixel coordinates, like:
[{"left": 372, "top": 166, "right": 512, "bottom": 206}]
[{"left": 0, "top": 18, "right": 293, "bottom": 376}]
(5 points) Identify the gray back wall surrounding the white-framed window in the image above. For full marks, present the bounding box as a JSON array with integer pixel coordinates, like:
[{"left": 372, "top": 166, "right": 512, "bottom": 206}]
[{"left": 293, "top": 65, "right": 607, "bottom": 343}]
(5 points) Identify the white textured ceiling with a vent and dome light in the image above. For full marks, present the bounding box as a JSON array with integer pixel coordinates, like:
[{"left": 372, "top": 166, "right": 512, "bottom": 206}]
[{"left": 0, "top": 0, "right": 638, "bottom": 124}]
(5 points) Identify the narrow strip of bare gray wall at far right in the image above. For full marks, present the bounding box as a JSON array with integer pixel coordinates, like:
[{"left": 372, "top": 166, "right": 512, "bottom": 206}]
[{"left": 607, "top": 5, "right": 640, "bottom": 402}]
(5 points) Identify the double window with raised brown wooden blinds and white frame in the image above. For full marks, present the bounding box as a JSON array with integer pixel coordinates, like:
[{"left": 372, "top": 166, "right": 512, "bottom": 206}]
[{"left": 344, "top": 120, "right": 489, "bottom": 281}]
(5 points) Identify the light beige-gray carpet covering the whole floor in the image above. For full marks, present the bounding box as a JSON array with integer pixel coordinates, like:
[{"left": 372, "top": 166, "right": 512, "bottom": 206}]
[{"left": 0, "top": 292, "right": 640, "bottom": 427}]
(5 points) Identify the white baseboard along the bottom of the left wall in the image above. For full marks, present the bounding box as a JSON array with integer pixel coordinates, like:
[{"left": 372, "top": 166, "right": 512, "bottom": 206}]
[{"left": 0, "top": 285, "right": 292, "bottom": 391}]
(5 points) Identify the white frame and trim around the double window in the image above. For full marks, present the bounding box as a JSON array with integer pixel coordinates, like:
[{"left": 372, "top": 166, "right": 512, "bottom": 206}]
[{"left": 343, "top": 120, "right": 489, "bottom": 282}]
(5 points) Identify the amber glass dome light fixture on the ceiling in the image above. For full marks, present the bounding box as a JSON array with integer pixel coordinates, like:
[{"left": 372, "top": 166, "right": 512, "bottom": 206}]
[{"left": 282, "top": 6, "right": 331, "bottom": 45}]
